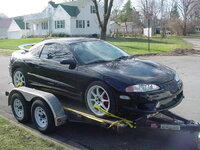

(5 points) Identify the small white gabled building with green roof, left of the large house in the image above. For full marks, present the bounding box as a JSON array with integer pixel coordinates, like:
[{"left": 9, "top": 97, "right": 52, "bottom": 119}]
[{"left": 8, "top": 19, "right": 30, "bottom": 39}]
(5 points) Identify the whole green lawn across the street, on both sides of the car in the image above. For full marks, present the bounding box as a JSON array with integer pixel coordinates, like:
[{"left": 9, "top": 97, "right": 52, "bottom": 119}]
[{"left": 0, "top": 36, "right": 192, "bottom": 54}]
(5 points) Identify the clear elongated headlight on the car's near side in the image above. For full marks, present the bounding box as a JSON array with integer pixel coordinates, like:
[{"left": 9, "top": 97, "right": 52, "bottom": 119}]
[{"left": 125, "top": 84, "right": 160, "bottom": 92}]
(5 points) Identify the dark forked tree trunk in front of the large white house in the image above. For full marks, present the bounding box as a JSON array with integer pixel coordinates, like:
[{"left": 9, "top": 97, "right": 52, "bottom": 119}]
[{"left": 92, "top": 0, "right": 114, "bottom": 40}]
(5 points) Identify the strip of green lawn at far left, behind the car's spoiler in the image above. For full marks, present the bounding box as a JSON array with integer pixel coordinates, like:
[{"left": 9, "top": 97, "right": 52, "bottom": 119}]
[{"left": 0, "top": 38, "right": 42, "bottom": 50}]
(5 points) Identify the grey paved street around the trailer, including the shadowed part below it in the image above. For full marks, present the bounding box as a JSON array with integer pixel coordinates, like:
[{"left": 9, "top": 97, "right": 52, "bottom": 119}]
[{"left": 0, "top": 55, "right": 200, "bottom": 150}]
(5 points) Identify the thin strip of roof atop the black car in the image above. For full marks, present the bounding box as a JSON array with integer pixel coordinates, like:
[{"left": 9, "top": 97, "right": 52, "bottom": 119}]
[{"left": 43, "top": 37, "right": 99, "bottom": 44}]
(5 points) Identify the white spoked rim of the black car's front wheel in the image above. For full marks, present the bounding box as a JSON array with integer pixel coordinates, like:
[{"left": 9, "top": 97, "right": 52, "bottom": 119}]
[{"left": 87, "top": 85, "right": 110, "bottom": 116}]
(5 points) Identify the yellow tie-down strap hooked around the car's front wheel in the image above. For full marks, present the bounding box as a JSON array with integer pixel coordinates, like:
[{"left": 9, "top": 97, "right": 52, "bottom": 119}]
[{"left": 94, "top": 104, "right": 136, "bottom": 128}]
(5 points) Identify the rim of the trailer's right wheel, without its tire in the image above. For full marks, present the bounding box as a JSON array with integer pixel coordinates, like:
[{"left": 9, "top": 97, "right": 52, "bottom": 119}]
[{"left": 34, "top": 107, "right": 48, "bottom": 128}]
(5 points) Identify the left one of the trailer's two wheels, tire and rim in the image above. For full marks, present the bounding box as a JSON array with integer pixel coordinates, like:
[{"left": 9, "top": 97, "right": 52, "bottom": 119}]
[{"left": 11, "top": 93, "right": 31, "bottom": 123}]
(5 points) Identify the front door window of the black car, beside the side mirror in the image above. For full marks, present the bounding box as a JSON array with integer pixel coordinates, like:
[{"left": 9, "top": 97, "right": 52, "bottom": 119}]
[{"left": 40, "top": 43, "right": 72, "bottom": 62}]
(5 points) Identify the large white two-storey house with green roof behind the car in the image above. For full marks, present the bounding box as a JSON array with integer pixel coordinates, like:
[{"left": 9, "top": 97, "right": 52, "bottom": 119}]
[{"left": 24, "top": 0, "right": 109, "bottom": 36}]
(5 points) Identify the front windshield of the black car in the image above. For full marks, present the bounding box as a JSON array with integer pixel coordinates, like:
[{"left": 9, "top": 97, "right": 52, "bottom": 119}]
[{"left": 71, "top": 41, "right": 129, "bottom": 64}]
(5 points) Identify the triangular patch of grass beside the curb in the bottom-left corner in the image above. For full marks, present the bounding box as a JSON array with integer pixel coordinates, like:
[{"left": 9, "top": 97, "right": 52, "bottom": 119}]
[{"left": 0, "top": 118, "right": 64, "bottom": 150}]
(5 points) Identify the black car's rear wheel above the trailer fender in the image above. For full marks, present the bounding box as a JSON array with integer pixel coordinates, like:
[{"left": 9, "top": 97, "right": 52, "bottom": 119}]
[{"left": 12, "top": 68, "right": 29, "bottom": 87}]
